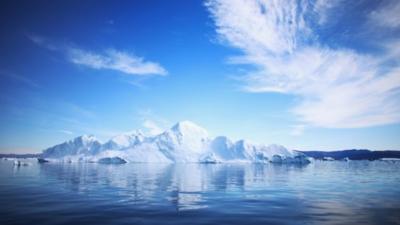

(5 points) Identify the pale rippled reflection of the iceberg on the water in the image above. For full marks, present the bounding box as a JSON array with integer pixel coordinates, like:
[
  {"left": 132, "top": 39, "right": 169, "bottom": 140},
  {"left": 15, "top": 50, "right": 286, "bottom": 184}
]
[{"left": 37, "top": 163, "right": 310, "bottom": 211}]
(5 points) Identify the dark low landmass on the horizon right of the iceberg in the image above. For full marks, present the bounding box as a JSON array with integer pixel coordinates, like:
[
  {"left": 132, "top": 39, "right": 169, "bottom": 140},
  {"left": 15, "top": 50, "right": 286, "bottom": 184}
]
[{"left": 299, "top": 149, "right": 400, "bottom": 160}]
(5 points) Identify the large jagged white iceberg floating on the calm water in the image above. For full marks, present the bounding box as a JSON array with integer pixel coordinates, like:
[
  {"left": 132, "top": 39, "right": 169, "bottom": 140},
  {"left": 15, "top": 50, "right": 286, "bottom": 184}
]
[{"left": 42, "top": 121, "right": 310, "bottom": 163}]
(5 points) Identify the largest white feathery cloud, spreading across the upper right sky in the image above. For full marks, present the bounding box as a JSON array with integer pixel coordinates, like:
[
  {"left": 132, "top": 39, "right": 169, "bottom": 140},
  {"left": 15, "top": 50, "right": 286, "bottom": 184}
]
[{"left": 206, "top": 0, "right": 400, "bottom": 128}]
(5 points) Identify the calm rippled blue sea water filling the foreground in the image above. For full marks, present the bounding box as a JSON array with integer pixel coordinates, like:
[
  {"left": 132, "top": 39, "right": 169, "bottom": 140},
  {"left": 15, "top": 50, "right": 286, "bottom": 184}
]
[{"left": 0, "top": 161, "right": 400, "bottom": 225}]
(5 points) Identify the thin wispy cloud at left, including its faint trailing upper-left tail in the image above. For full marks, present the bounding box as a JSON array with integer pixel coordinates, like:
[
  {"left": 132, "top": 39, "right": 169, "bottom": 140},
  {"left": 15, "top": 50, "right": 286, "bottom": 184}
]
[{"left": 28, "top": 34, "right": 168, "bottom": 76}]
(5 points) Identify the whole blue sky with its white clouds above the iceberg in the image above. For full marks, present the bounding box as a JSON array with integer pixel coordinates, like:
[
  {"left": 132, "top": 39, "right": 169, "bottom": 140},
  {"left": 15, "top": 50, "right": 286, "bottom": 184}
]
[{"left": 0, "top": 0, "right": 400, "bottom": 153}]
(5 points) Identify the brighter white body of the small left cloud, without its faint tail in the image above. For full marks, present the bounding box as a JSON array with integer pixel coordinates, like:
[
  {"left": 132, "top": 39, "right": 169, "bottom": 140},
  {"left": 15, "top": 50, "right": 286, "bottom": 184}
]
[{"left": 68, "top": 48, "right": 167, "bottom": 75}]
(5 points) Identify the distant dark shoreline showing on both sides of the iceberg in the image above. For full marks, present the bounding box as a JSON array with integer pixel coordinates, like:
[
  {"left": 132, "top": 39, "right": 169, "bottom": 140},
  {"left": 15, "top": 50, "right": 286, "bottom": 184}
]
[{"left": 0, "top": 149, "right": 400, "bottom": 160}]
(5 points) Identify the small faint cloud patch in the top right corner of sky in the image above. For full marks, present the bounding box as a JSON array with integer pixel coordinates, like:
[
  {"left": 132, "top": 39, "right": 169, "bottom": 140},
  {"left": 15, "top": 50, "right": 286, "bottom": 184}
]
[{"left": 369, "top": 0, "right": 400, "bottom": 28}]
